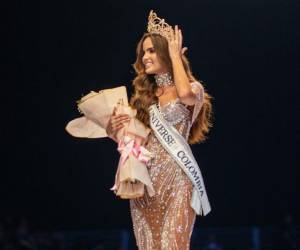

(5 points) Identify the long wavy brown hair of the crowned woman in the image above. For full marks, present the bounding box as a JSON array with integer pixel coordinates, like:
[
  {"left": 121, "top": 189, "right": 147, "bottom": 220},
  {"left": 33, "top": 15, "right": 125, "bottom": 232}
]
[{"left": 130, "top": 33, "right": 213, "bottom": 144}]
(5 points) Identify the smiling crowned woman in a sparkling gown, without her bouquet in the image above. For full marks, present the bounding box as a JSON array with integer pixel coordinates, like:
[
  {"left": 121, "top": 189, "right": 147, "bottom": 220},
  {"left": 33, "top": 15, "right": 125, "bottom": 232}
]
[{"left": 107, "top": 11, "right": 212, "bottom": 250}]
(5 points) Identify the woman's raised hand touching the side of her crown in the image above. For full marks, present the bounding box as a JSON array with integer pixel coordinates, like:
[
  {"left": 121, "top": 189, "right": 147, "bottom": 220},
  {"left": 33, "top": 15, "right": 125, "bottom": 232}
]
[{"left": 167, "top": 25, "right": 187, "bottom": 60}]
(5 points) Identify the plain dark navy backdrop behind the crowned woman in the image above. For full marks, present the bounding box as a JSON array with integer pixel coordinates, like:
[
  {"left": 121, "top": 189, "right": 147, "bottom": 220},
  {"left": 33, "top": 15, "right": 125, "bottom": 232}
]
[{"left": 0, "top": 0, "right": 300, "bottom": 229}]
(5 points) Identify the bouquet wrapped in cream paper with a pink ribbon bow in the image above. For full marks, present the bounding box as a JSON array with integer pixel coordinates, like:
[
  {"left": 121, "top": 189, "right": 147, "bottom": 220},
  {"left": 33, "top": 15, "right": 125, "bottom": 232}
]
[{"left": 66, "top": 86, "right": 154, "bottom": 199}]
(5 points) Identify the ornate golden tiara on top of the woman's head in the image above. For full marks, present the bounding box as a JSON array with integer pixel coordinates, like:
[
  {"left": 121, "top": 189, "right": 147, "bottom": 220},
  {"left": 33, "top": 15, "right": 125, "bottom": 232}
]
[{"left": 147, "top": 10, "right": 174, "bottom": 40}]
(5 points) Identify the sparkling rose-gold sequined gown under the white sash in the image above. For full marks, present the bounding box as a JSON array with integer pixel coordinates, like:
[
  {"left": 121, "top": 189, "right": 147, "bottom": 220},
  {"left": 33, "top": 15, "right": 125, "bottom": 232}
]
[{"left": 130, "top": 82, "right": 203, "bottom": 250}]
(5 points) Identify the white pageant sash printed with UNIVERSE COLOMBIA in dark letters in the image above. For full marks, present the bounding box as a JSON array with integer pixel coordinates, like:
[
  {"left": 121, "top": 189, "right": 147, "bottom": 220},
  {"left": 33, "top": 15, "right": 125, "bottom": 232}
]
[{"left": 149, "top": 104, "right": 211, "bottom": 216}]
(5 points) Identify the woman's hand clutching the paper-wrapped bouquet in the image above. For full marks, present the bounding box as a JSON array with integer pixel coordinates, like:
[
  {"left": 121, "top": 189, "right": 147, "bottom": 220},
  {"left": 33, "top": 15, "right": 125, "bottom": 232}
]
[{"left": 106, "top": 107, "right": 130, "bottom": 142}]
